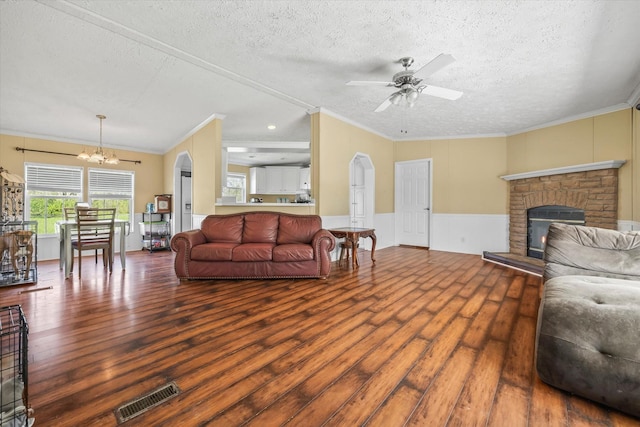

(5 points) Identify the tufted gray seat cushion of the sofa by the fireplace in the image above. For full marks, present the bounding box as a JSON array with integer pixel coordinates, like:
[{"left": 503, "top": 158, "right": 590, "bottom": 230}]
[{"left": 535, "top": 276, "right": 640, "bottom": 416}]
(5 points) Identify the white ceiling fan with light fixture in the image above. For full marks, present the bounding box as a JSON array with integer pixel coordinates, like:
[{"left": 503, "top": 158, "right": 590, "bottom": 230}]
[{"left": 347, "top": 53, "right": 462, "bottom": 113}]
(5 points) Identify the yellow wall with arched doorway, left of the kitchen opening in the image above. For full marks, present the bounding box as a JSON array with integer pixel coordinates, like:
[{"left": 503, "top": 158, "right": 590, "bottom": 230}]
[{"left": 163, "top": 119, "right": 222, "bottom": 215}]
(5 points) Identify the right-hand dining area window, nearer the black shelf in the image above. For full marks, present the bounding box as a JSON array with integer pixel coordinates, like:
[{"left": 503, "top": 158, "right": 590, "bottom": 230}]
[{"left": 89, "top": 168, "right": 134, "bottom": 222}]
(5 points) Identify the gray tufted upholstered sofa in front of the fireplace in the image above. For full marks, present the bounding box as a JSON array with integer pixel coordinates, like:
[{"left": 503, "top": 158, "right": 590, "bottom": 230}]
[{"left": 535, "top": 223, "right": 640, "bottom": 417}]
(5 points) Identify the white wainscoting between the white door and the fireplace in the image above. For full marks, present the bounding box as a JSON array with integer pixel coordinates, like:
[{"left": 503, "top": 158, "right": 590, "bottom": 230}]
[{"left": 431, "top": 213, "right": 509, "bottom": 254}]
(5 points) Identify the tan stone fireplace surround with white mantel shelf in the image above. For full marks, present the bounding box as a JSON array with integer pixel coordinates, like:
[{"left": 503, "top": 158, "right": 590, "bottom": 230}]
[{"left": 502, "top": 160, "right": 625, "bottom": 256}]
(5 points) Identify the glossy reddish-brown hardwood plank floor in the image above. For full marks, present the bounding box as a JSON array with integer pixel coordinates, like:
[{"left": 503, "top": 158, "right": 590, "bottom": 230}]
[{"left": 0, "top": 247, "right": 640, "bottom": 426}]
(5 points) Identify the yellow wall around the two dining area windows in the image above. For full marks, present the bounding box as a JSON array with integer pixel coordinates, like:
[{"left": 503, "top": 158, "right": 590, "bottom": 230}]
[{"left": 0, "top": 134, "right": 165, "bottom": 212}]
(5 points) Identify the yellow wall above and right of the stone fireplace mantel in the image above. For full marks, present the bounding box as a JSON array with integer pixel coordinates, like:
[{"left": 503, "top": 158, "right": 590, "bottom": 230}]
[{"left": 507, "top": 108, "right": 640, "bottom": 221}]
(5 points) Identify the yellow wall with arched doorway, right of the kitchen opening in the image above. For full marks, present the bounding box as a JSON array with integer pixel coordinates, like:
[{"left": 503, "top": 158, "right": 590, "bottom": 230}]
[{"left": 311, "top": 113, "right": 394, "bottom": 216}]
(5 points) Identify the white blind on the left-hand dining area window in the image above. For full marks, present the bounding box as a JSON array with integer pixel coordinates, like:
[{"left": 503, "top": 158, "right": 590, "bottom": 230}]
[{"left": 25, "top": 163, "right": 83, "bottom": 194}]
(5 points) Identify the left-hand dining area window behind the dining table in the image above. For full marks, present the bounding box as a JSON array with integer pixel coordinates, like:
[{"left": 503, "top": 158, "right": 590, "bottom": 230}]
[{"left": 24, "top": 163, "right": 83, "bottom": 234}]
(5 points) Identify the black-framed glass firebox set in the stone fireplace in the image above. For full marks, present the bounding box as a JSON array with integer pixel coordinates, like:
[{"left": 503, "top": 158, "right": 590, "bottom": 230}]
[{"left": 527, "top": 205, "right": 585, "bottom": 259}]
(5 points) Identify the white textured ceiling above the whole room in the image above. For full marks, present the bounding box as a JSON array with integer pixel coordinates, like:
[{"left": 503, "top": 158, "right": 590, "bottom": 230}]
[{"left": 0, "top": 0, "right": 640, "bottom": 162}]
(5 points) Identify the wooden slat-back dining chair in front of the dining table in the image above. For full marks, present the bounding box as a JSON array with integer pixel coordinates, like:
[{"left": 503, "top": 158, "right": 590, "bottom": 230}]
[{"left": 71, "top": 208, "right": 116, "bottom": 277}]
